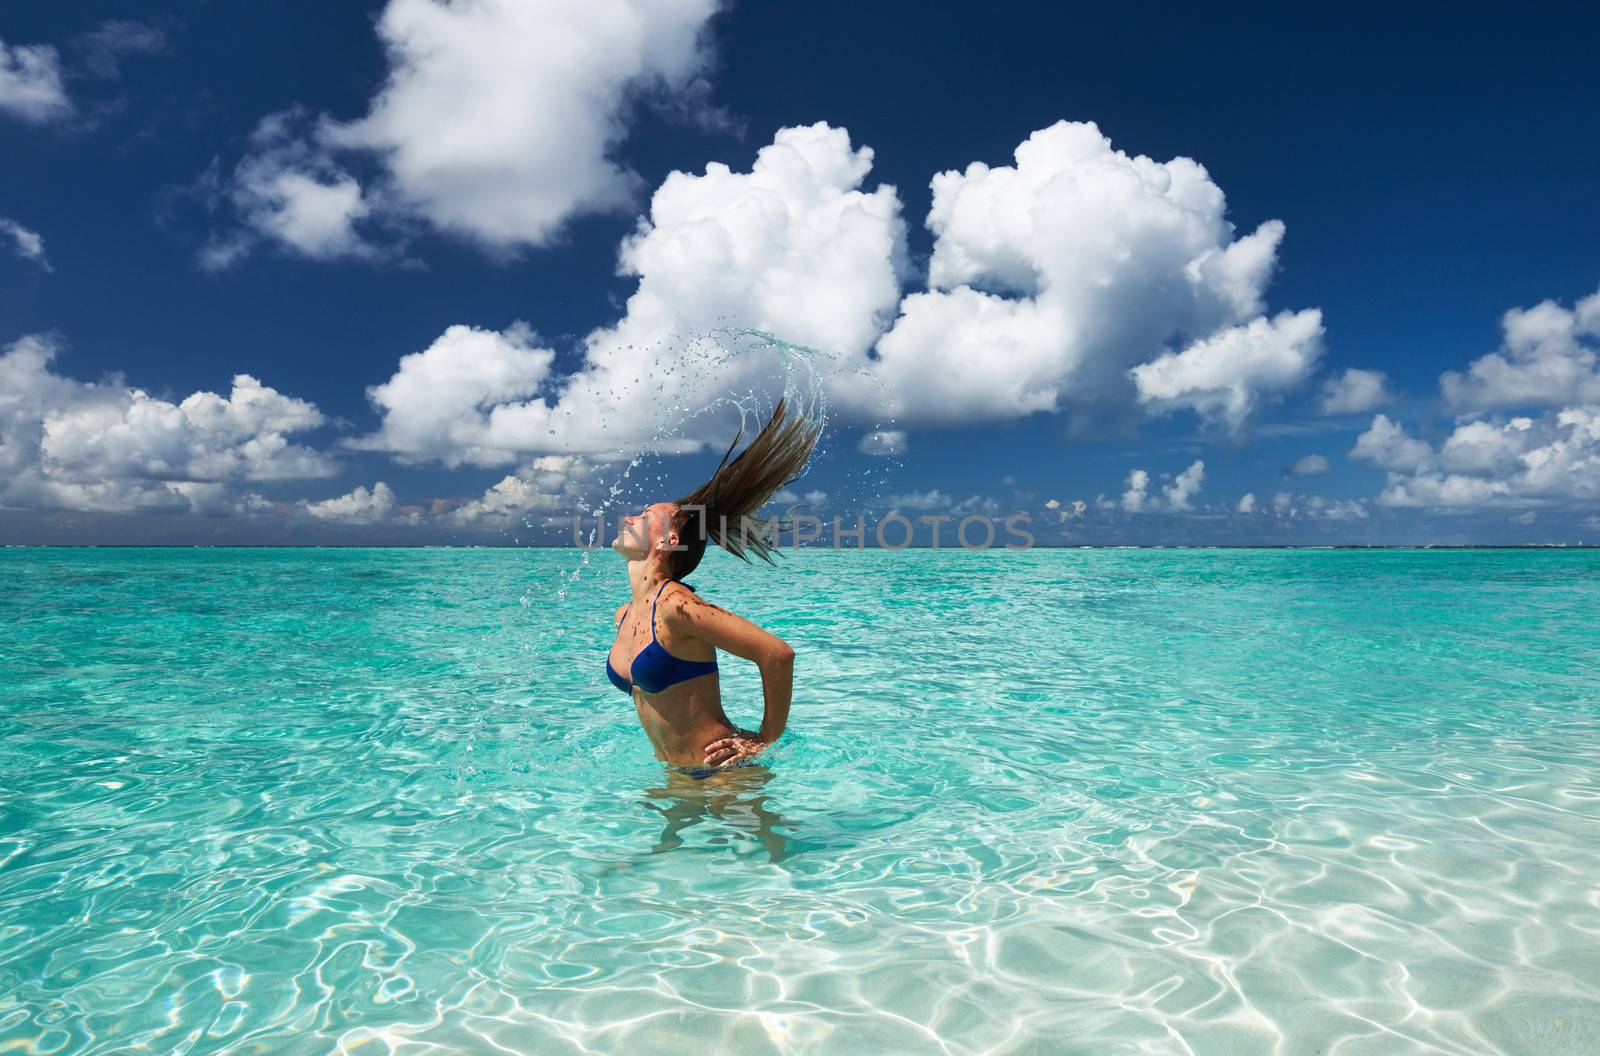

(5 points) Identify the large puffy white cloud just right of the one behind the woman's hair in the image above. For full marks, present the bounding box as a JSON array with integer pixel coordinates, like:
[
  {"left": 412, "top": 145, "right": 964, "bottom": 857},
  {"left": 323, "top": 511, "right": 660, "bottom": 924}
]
[{"left": 877, "top": 122, "right": 1320, "bottom": 422}]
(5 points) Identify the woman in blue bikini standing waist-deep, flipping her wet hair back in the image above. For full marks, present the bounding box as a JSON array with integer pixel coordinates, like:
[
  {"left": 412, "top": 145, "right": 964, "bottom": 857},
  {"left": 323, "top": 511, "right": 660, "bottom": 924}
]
[{"left": 606, "top": 400, "right": 821, "bottom": 778}]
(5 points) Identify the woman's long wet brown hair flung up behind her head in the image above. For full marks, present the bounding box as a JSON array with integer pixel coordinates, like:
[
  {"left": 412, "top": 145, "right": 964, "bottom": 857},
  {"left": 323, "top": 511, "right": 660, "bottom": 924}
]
[{"left": 667, "top": 397, "right": 822, "bottom": 579}]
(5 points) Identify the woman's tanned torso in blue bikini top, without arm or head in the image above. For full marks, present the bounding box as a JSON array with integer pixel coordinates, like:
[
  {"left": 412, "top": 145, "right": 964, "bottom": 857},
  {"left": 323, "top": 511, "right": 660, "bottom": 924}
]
[{"left": 606, "top": 581, "right": 734, "bottom": 766}]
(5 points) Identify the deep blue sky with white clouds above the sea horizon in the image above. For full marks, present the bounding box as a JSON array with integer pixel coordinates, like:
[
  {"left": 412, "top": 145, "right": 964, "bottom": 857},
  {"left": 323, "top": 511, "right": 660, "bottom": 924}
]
[{"left": 0, "top": 0, "right": 1600, "bottom": 544}]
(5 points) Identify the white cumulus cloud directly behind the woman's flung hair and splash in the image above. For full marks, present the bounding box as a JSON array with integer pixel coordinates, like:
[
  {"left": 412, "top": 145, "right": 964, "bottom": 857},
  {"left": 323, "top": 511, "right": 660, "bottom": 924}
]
[{"left": 362, "top": 123, "right": 904, "bottom": 466}]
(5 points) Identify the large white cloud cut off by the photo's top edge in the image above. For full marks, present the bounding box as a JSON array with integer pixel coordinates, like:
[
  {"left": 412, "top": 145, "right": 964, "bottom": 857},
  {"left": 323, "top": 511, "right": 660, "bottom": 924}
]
[{"left": 211, "top": 0, "right": 717, "bottom": 258}]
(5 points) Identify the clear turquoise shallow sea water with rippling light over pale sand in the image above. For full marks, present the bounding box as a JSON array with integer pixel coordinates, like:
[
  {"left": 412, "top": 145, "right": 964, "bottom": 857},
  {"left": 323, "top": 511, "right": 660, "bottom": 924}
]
[{"left": 0, "top": 550, "right": 1600, "bottom": 1054}]
